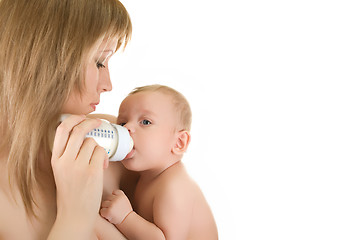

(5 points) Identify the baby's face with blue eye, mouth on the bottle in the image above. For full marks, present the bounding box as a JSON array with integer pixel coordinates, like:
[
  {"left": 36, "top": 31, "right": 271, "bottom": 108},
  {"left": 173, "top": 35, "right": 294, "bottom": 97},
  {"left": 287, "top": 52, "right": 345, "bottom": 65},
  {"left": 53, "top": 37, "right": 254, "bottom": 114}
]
[{"left": 117, "top": 91, "right": 178, "bottom": 171}]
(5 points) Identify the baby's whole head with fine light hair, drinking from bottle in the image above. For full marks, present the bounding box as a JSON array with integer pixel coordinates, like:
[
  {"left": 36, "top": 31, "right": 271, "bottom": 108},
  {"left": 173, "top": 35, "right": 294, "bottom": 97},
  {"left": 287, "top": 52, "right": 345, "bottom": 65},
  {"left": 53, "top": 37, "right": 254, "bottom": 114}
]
[{"left": 117, "top": 84, "right": 192, "bottom": 171}]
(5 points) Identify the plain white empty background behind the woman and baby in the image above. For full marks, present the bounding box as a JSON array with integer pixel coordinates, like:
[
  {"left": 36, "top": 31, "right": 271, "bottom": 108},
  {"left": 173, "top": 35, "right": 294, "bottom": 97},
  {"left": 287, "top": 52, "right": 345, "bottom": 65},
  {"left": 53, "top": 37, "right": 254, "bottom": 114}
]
[{"left": 96, "top": 0, "right": 359, "bottom": 240}]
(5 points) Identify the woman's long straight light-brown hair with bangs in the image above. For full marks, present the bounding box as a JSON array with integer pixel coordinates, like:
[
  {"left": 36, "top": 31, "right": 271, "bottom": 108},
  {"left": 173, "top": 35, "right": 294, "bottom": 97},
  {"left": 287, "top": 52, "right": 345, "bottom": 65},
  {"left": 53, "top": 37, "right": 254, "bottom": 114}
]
[{"left": 0, "top": 0, "right": 132, "bottom": 216}]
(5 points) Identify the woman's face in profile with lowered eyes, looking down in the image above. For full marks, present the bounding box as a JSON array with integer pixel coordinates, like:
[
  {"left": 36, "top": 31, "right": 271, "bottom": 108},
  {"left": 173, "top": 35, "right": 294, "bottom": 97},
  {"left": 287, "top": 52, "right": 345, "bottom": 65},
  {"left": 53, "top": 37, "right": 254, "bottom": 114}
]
[{"left": 62, "top": 39, "right": 117, "bottom": 115}]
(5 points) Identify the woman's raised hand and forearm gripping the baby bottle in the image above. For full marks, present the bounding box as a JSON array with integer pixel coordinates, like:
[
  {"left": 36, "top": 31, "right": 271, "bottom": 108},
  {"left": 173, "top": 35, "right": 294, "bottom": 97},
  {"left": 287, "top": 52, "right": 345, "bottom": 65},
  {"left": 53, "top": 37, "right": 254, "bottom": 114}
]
[{"left": 50, "top": 115, "right": 108, "bottom": 239}]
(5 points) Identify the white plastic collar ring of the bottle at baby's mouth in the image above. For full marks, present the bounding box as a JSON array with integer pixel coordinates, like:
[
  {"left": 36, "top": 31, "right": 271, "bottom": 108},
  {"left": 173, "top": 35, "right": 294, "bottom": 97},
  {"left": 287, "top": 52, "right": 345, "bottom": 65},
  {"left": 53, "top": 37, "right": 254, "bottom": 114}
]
[{"left": 110, "top": 123, "right": 133, "bottom": 161}]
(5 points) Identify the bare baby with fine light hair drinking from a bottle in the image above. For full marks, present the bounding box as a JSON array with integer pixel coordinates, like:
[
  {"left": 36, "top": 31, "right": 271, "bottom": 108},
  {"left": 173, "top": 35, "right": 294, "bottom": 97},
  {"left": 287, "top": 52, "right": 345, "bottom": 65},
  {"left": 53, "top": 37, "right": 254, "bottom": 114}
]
[{"left": 100, "top": 85, "right": 218, "bottom": 240}]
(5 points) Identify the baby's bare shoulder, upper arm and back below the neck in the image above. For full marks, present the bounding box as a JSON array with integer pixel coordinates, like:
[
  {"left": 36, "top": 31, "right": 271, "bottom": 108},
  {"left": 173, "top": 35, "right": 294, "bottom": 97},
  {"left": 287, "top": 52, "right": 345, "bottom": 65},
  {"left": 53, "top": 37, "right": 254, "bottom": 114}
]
[{"left": 153, "top": 162, "right": 217, "bottom": 240}]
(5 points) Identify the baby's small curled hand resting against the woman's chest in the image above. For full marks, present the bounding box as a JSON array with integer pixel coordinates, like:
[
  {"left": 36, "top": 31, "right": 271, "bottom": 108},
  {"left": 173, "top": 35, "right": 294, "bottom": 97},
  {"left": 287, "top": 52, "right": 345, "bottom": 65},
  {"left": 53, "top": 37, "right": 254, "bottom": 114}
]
[{"left": 100, "top": 190, "right": 133, "bottom": 224}]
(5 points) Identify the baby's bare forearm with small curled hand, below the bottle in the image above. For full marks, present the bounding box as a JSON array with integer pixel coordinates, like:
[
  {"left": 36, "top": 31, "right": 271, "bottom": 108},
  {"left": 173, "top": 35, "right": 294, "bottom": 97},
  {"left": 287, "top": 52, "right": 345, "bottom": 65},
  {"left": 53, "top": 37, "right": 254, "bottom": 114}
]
[{"left": 100, "top": 190, "right": 166, "bottom": 240}]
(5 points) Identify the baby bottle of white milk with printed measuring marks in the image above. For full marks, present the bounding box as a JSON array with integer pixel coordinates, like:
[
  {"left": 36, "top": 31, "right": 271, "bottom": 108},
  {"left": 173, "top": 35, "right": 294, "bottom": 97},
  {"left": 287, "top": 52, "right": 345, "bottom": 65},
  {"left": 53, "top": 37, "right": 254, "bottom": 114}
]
[{"left": 61, "top": 114, "right": 133, "bottom": 161}]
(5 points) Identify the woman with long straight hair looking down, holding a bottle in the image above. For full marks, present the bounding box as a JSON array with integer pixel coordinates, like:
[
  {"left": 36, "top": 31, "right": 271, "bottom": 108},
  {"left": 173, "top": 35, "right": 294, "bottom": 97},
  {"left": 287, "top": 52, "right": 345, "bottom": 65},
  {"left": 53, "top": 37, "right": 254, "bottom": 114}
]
[{"left": 0, "top": 0, "right": 132, "bottom": 239}]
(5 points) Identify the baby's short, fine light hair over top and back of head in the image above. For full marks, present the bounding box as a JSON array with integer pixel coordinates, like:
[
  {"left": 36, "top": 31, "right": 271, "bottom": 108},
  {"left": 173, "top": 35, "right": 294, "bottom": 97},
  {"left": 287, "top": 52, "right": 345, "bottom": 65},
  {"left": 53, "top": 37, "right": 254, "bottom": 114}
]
[{"left": 128, "top": 84, "right": 192, "bottom": 131}]
